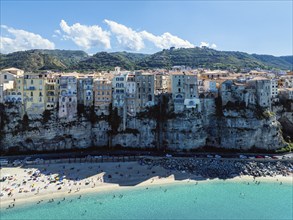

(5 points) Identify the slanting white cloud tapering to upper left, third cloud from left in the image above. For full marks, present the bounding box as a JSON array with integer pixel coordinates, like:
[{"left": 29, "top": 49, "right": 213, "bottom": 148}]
[{"left": 104, "top": 19, "right": 144, "bottom": 51}]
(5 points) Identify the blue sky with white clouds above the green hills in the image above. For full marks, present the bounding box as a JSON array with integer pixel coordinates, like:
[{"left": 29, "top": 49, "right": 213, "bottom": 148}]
[{"left": 0, "top": 0, "right": 293, "bottom": 56}]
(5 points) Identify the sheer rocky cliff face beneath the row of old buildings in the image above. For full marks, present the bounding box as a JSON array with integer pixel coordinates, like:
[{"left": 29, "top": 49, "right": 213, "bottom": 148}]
[{"left": 0, "top": 99, "right": 284, "bottom": 152}]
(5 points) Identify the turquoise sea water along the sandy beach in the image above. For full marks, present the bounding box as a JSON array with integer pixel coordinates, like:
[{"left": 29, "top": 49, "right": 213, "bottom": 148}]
[{"left": 0, "top": 181, "right": 293, "bottom": 220}]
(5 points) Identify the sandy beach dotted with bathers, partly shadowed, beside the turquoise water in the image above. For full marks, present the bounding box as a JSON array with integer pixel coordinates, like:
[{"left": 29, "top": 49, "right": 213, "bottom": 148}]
[{"left": 0, "top": 162, "right": 293, "bottom": 208}]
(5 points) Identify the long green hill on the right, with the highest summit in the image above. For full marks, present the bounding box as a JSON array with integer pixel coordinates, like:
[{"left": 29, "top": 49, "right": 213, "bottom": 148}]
[{"left": 137, "top": 47, "right": 292, "bottom": 70}]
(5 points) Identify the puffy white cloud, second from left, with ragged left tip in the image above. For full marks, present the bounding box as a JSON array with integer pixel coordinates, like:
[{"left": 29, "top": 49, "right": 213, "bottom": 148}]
[{"left": 59, "top": 20, "right": 111, "bottom": 50}]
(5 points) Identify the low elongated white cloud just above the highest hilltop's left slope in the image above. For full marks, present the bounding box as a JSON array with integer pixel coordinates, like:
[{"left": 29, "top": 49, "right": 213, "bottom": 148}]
[{"left": 140, "top": 31, "right": 194, "bottom": 49}]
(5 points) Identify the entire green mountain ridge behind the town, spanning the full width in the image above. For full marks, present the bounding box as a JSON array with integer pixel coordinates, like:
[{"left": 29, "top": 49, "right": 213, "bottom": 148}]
[{"left": 0, "top": 47, "right": 293, "bottom": 71}]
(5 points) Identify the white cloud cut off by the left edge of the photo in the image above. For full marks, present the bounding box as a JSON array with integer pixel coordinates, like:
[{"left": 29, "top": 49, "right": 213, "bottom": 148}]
[{"left": 0, "top": 25, "right": 55, "bottom": 53}]
